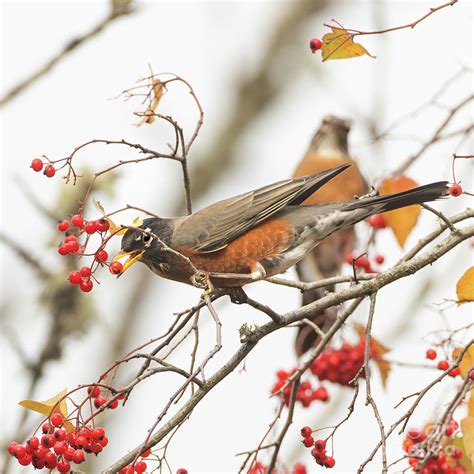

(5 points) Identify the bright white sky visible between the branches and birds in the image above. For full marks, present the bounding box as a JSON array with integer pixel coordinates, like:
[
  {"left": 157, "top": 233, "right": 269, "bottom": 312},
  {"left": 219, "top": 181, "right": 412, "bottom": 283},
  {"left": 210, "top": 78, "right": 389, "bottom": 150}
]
[{"left": 1, "top": 1, "right": 473, "bottom": 473}]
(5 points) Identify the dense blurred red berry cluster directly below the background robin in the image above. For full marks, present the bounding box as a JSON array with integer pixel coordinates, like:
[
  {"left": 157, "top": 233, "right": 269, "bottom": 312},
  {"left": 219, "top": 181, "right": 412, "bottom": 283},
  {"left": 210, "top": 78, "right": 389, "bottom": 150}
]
[{"left": 311, "top": 338, "right": 366, "bottom": 386}]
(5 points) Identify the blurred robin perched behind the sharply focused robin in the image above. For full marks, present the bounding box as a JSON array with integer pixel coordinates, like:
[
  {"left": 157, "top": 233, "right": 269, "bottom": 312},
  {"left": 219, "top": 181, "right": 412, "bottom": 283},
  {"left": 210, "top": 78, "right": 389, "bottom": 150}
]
[{"left": 293, "top": 115, "right": 368, "bottom": 356}]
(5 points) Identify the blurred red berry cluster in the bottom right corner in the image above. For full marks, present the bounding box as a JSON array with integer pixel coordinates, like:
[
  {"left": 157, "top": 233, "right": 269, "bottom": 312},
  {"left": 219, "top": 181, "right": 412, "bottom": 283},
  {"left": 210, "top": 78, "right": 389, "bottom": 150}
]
[{"left": 403, "top": 420, "right": 467, "bottom": 474}]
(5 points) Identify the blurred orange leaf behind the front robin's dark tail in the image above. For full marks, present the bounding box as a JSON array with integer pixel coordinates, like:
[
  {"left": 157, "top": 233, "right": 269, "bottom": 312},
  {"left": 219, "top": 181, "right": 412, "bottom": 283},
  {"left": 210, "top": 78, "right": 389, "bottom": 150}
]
[{"left": 379, "top": 176, "right": 421, "bottom": 247}]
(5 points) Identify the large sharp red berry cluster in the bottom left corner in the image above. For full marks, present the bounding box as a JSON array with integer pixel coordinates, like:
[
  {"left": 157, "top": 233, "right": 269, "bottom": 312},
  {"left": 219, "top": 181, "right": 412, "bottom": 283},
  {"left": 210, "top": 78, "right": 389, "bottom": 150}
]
[{"left": 7, "top": 413, "right": 109, "bottom": 472}]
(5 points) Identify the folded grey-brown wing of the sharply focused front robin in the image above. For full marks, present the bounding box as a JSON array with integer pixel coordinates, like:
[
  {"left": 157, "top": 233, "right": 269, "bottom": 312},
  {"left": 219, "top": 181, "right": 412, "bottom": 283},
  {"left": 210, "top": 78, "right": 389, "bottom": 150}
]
[{"left": 173, "top": 164, "right": 350, "bottom": 253}]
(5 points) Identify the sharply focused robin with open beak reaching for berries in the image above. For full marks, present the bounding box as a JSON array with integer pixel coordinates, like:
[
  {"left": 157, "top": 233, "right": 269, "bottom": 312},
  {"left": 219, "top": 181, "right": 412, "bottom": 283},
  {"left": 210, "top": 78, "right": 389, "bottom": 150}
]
[{"left": 114, "top": 164, "right": 447, "bottom": 288}]
